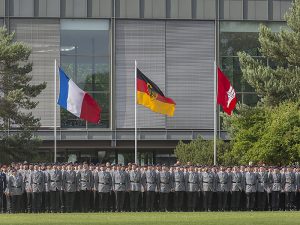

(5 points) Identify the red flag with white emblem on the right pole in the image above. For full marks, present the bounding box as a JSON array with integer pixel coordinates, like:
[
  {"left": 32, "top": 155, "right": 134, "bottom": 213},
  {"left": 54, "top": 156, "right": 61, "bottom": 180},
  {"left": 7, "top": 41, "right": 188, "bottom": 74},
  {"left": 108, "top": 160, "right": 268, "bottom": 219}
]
[{"left": 217, "top": 68, "right": 236, "bottom": 115}]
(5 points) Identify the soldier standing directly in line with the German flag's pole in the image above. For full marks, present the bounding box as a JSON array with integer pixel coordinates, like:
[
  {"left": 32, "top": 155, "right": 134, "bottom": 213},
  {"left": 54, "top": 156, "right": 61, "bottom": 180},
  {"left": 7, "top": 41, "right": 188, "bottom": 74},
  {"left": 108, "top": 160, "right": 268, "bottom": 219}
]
[{"left": 129, "top": 163, "right": 143, "bottom": 212}]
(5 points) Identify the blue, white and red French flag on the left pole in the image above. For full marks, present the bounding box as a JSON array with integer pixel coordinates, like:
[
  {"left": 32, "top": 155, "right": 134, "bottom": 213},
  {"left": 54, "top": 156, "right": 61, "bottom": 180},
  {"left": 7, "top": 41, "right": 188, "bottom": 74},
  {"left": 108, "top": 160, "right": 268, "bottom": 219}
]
[{"left": 57, "top": 68, "right": 101, "bottom": 124}]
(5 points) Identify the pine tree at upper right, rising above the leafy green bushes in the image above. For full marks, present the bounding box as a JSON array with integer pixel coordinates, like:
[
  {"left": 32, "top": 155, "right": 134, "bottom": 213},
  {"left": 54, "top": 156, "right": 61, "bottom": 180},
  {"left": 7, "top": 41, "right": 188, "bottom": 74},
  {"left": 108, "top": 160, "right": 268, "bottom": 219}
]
[{"left": 238, "top": 0, "right": 300, "bottom": 106}]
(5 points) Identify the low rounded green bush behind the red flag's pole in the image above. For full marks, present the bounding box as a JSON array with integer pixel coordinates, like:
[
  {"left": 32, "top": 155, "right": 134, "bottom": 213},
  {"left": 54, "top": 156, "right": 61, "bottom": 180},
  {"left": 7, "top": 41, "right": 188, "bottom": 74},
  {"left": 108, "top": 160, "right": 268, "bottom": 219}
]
[{"left": 174, "top": 137, "right": 232, "bottom": 165}]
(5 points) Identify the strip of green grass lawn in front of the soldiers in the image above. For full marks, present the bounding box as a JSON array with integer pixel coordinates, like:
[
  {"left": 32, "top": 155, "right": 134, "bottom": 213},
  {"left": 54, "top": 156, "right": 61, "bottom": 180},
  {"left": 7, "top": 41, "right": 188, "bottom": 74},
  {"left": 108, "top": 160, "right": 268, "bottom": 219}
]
[{"left": 0, "top": 212, "right": 300, "bottom": 225}]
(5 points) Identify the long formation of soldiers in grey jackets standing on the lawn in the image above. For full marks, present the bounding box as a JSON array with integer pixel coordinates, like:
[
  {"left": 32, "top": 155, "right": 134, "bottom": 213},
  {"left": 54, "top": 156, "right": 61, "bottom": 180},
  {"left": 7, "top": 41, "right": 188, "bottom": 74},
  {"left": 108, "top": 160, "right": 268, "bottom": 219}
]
[{"left": 0, "top": 162, "right": 300, "bottom": 213}]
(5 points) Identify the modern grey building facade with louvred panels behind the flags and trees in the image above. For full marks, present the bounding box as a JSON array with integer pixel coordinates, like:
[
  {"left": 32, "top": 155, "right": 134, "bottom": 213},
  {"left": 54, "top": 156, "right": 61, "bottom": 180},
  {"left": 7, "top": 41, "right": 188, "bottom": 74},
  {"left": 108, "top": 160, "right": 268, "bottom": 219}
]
[{"left": 0, "top": 0, "right": 292, "bottom": 164}]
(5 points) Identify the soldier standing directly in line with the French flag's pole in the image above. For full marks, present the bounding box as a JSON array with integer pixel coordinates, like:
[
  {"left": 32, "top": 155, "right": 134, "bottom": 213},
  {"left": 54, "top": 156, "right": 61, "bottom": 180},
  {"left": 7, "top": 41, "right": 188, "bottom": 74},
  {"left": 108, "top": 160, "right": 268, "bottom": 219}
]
[{"left": 48, "top": 164, "right": 62, "bottom": 213}]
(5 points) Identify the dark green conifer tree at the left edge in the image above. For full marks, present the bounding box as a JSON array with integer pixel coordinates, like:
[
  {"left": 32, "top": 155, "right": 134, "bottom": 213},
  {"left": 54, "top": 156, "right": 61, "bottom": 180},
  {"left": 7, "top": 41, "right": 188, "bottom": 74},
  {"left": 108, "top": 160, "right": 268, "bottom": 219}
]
[{"left": 0, "top": 27, "right": 46, "bottom": 162}]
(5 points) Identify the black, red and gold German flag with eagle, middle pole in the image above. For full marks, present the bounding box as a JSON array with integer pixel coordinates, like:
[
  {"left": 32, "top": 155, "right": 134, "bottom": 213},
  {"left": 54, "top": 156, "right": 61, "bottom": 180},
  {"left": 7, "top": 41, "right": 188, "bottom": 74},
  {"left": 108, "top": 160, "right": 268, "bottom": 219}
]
[{"left": 136, "top": 68, "right": 176, "bottom": 116}]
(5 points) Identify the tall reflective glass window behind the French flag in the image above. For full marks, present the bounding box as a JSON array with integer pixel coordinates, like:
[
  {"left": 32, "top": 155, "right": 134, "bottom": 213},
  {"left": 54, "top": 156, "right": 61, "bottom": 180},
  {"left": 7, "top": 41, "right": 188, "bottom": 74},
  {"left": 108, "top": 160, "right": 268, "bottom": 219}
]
[{"left": 60, "top": 19, "right": 110, "bottom": 128}]
